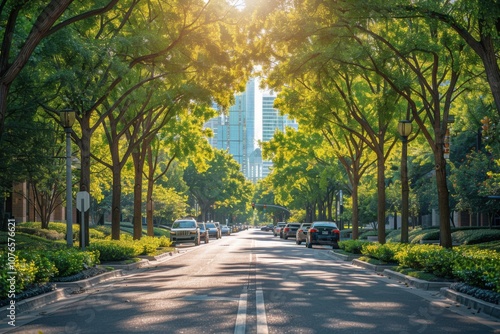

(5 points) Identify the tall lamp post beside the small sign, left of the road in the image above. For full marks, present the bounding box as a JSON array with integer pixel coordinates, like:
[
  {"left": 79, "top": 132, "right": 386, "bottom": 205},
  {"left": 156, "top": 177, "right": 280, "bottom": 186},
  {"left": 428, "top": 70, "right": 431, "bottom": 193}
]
[{"left": 59, "top": 110, "right": 75, "bottom": 247}]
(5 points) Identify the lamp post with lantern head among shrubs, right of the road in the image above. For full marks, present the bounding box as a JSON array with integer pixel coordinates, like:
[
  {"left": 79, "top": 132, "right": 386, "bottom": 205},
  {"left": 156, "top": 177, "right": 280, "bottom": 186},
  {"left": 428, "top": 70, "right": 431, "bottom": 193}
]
[{"left": 398, "top": 120, "right": 412, "bottom": 243}]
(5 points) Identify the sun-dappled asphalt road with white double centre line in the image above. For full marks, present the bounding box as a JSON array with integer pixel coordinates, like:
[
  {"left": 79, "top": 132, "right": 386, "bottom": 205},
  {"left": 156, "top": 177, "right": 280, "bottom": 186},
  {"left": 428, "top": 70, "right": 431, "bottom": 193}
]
[{"left": 2, "top": 230, "right": 500, "bottom": 334}]
